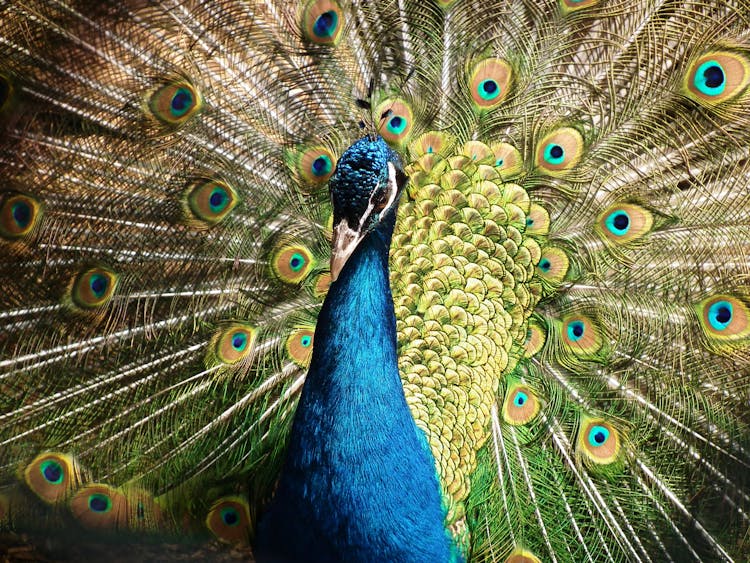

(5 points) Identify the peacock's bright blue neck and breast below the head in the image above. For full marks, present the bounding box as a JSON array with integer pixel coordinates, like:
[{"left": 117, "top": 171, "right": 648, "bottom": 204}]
[{"left": 257, "top": 215, "right": 453, "bottom": 562}]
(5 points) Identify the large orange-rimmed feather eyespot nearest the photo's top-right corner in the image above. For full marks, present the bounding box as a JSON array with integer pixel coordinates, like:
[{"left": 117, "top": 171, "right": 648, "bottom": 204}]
[{"left": 683, "top": 51, "right": 750, "bottom": 107}]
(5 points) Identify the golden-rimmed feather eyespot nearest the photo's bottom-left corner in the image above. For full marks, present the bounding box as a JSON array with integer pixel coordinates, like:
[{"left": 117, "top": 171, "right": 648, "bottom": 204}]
[{"left": 24, "top": 453, "right": 80, "bottom": 504}]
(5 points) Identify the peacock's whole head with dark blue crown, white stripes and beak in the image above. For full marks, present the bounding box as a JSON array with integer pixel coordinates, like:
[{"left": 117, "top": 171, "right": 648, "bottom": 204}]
[{"left": 329, "top": 135, "right": 409, "bottom": 281}]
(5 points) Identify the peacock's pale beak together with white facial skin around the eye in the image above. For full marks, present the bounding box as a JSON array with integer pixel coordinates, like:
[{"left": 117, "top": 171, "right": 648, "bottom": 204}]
[{"left": 331, "top": 162, "right": 406, "bottom": 281}]
